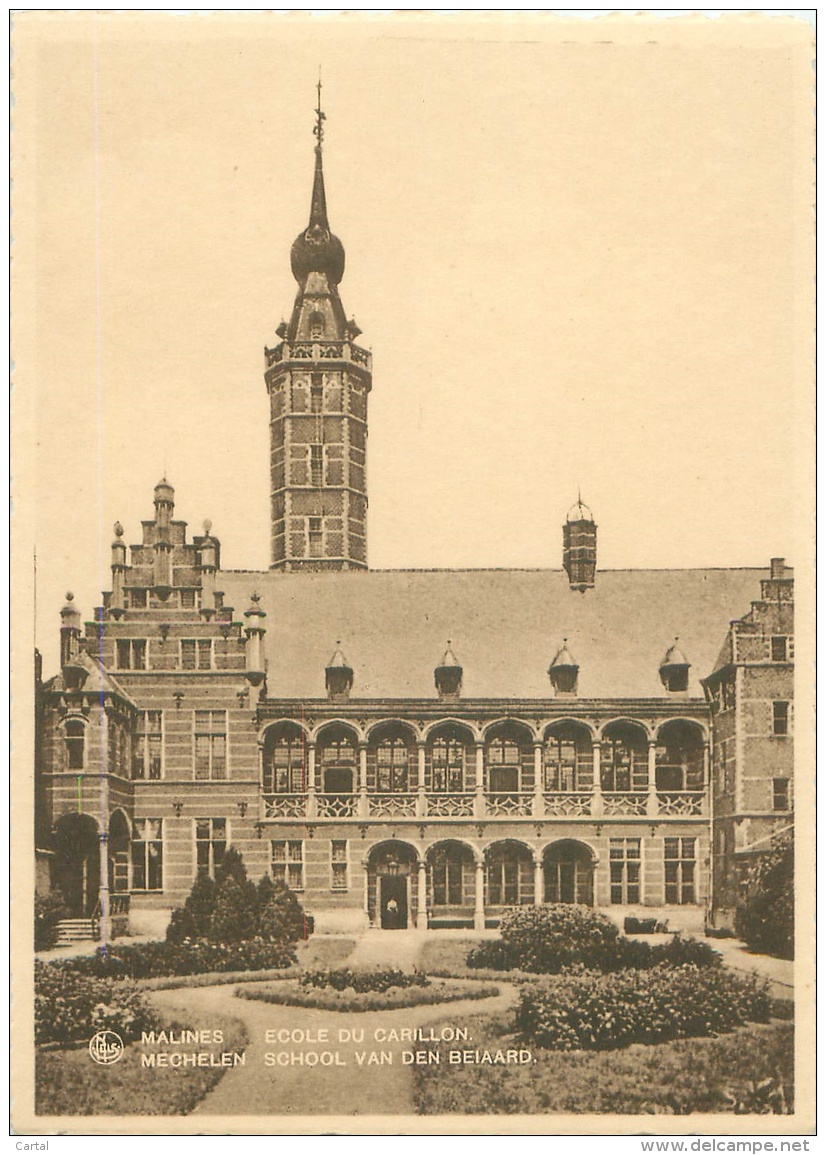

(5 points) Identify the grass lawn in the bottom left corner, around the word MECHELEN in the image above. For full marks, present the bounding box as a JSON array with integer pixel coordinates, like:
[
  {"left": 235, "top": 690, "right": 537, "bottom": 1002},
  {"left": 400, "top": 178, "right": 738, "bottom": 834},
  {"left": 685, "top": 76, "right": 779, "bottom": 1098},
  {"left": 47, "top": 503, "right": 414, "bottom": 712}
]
[{"left": 35, "top": 1015, "right": 247, "bottom": 1115}]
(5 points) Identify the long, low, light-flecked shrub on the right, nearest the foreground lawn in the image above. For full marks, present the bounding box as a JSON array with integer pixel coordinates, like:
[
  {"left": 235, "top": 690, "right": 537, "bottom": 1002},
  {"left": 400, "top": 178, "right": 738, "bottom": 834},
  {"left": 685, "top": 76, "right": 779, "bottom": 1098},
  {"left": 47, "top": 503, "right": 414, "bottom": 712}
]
[{"left": 516, "top": 966, "right": 771, "bottom": 1051}]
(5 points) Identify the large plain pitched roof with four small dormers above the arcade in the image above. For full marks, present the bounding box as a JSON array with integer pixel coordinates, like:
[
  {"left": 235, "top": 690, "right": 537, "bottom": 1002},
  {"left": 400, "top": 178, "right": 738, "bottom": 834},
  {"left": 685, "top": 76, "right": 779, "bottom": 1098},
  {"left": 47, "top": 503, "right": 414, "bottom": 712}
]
[{"left": 218, "top": 569, "right": 767, "bottom": 699}]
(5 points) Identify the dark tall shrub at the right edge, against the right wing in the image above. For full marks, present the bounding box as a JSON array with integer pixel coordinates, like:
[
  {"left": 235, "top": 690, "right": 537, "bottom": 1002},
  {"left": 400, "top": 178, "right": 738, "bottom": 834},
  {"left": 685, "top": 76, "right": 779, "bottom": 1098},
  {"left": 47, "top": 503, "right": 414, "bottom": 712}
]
[{"left": 735, "top": 834, "right": 795, "bottom": 959}]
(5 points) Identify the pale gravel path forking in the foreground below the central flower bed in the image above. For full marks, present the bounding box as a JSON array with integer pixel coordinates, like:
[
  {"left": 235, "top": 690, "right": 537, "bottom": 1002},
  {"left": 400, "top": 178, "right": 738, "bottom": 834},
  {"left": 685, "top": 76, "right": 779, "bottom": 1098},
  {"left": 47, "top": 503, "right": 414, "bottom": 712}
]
[{"left": 145, "top": 984, "right": 516, "bottom": 1117}]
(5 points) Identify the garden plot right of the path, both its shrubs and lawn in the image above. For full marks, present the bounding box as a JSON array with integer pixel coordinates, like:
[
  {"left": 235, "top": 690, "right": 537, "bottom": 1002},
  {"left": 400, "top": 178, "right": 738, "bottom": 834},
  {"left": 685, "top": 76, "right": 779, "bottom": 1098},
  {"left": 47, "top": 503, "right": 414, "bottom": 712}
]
[{"left": 415, "top": 906, "right": 794, "bottom": 1115}]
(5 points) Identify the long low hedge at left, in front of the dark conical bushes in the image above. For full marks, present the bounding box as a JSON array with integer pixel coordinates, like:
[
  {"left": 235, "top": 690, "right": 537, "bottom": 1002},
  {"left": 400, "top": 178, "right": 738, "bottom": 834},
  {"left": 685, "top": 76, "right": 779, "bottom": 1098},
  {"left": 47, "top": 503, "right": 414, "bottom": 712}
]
[{"left": 57, "top": 939, "right": 296, "bottom": 978}]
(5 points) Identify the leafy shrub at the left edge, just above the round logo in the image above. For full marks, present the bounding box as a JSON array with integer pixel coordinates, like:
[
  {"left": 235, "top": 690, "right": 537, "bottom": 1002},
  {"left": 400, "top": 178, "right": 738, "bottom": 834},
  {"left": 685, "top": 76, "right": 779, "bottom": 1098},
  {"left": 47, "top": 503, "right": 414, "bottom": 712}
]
[{"left": 35, "top": 961, "right": 154, "bottom": 1043}]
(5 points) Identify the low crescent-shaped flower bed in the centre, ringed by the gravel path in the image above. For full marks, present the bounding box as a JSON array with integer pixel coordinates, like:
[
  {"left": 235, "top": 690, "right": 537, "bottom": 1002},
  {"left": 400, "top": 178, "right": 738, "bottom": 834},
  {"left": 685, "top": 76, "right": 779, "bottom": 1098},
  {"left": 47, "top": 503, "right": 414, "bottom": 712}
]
[{"left": 236, "top": 979, "right": 499, "bottom": 1013}]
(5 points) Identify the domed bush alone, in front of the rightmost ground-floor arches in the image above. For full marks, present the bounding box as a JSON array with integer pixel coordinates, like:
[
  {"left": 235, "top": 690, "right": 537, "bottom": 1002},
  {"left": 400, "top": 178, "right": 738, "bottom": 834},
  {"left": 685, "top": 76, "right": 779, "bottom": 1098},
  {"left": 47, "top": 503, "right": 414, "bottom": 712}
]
[{"left": 500, "top": 902, "right": 619, "bottom": 975}]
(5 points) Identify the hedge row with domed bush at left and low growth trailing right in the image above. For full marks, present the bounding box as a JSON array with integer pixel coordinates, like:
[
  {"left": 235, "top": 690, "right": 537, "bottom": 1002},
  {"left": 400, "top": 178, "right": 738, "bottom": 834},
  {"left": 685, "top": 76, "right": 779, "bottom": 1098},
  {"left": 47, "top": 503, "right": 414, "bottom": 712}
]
[{"left": 467, "top": 903, "right": 722, "bottom": 975}]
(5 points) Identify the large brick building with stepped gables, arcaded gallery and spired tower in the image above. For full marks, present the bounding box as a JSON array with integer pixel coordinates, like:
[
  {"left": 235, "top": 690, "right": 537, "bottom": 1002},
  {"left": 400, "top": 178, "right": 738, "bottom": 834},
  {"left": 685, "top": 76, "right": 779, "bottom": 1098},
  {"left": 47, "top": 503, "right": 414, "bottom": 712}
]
[{"left": 36, "top": 108, "right": 792, "bottom": 934}]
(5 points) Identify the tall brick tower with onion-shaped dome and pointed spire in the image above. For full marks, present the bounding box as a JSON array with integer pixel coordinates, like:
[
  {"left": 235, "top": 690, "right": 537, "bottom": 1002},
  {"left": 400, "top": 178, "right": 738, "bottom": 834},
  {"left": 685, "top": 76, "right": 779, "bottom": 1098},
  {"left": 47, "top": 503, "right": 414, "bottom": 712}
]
[{"left": 265, "top": 90, "right": 372, "bottom": 572}]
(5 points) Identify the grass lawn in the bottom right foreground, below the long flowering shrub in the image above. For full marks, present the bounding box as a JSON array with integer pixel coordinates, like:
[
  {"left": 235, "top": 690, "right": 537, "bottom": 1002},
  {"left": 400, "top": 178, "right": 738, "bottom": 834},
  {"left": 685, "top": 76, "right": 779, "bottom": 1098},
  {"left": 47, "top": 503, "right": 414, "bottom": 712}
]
[{"left": 414, "top": 1015, "right": 794, "bottom": 1115}]
